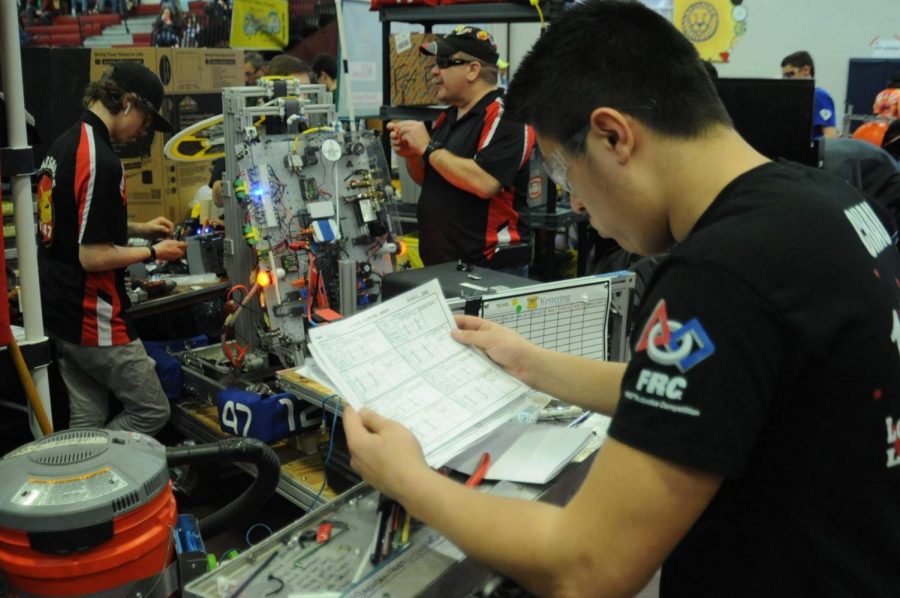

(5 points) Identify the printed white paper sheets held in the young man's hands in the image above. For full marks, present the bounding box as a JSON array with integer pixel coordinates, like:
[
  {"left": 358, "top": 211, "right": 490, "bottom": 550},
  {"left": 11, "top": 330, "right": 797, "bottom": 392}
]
[{"left": 309, "top": 280, "right": 530, "bottom": 467}]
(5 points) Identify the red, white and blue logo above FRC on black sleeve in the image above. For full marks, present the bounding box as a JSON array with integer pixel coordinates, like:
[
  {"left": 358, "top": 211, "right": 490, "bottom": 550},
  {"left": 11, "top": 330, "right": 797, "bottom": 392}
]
[{"left": 635, "top": 299, "right": 716, "bottom": 373}]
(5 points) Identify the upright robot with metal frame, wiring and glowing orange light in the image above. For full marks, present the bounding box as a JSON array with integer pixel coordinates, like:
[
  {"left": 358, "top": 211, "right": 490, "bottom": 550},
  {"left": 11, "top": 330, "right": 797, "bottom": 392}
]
[{"left": 216, "top": 77, "right": 402, "bottom": 369}]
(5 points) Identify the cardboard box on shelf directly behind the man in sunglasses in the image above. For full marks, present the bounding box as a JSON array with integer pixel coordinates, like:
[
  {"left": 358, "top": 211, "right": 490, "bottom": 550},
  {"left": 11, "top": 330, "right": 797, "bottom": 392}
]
[{"left": 390, "top": 33, "right": 439, "bottom": 106}]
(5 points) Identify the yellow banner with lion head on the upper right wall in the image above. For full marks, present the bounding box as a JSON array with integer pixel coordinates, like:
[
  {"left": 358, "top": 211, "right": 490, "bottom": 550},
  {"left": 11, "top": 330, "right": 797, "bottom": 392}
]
[{"left": 672, "top": 0, "right": 747, "bottom": 62}]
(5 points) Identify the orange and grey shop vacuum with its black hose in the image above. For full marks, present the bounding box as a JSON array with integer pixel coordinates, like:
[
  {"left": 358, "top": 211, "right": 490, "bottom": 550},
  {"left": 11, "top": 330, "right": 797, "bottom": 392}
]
[{"left": 0, "top": 429, "right": 280, "bottom": 598}]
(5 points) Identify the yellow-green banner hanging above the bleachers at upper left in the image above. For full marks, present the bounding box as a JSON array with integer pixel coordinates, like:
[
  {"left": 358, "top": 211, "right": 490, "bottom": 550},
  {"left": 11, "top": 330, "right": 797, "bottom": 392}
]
[{"left": 230, "top": 0, "right": 289, "bottom": 50}]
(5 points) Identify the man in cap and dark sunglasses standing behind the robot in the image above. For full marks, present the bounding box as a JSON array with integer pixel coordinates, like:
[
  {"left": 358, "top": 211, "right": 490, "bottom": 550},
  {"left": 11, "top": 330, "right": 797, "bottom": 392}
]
[{"left": 388, "top": 26, "right": 534, "bottom": 276}]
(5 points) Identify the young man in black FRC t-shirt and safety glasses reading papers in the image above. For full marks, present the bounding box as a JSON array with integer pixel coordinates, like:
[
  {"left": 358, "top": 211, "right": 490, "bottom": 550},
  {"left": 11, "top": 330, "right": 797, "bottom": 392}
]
[{"left": 344, "top": 0, "right": 900, "bottom": 597}]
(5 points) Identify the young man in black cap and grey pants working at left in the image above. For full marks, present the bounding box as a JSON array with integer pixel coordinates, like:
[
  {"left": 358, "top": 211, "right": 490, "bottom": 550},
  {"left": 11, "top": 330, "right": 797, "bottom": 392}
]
[{"left": 38, "top": 62, "right": 185, "bottom": 434}]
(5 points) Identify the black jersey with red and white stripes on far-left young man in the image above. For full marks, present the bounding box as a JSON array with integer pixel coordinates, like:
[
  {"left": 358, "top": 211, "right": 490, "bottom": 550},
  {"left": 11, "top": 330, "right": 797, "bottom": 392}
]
[{"left": 38, "top": 112, "right": 137, "bottom": 346}]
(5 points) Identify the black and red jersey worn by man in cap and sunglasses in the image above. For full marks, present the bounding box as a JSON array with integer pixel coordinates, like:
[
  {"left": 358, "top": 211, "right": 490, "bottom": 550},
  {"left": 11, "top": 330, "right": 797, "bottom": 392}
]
[{"left": 418, "top": 90, "right": 535, "bottom": 266}]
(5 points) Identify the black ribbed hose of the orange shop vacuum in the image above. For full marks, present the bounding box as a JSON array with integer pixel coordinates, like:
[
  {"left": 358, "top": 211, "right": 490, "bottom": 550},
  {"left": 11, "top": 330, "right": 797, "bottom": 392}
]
[{"left": 166, "top": 438, "right": 281, "bottom": 537}]
